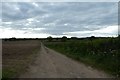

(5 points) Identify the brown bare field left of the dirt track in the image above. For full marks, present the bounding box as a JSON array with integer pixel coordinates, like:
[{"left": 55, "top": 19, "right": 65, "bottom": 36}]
[{"left": 2, "top": 40, "right": 40, "bottom": 78}]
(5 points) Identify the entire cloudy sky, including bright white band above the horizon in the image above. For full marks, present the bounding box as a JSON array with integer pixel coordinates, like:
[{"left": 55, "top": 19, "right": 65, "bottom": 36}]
[{"left": 0, "top": 2, "right": 118, "bottom": 38}]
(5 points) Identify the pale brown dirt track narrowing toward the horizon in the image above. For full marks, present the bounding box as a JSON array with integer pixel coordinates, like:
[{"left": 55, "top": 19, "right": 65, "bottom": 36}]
[{"left": 20, "top": 44, "right": 109, "bottom": 78}]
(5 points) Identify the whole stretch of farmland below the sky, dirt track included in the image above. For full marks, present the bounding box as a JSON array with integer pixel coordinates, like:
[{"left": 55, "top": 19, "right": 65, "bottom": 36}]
[{"left": 2, "top": 37, "right": 120, "bottom": 78}]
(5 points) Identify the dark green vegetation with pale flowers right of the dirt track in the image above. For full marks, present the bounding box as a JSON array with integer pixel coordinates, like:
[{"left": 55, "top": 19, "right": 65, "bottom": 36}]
[{"left": 45, "top": 36, "right": 120, "bottom": 77}]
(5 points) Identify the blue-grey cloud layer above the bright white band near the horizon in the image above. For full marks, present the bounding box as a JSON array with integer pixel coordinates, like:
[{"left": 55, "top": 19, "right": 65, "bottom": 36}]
[{"left": 2, "top": 2, "right": 118, "bottom": 35}]
